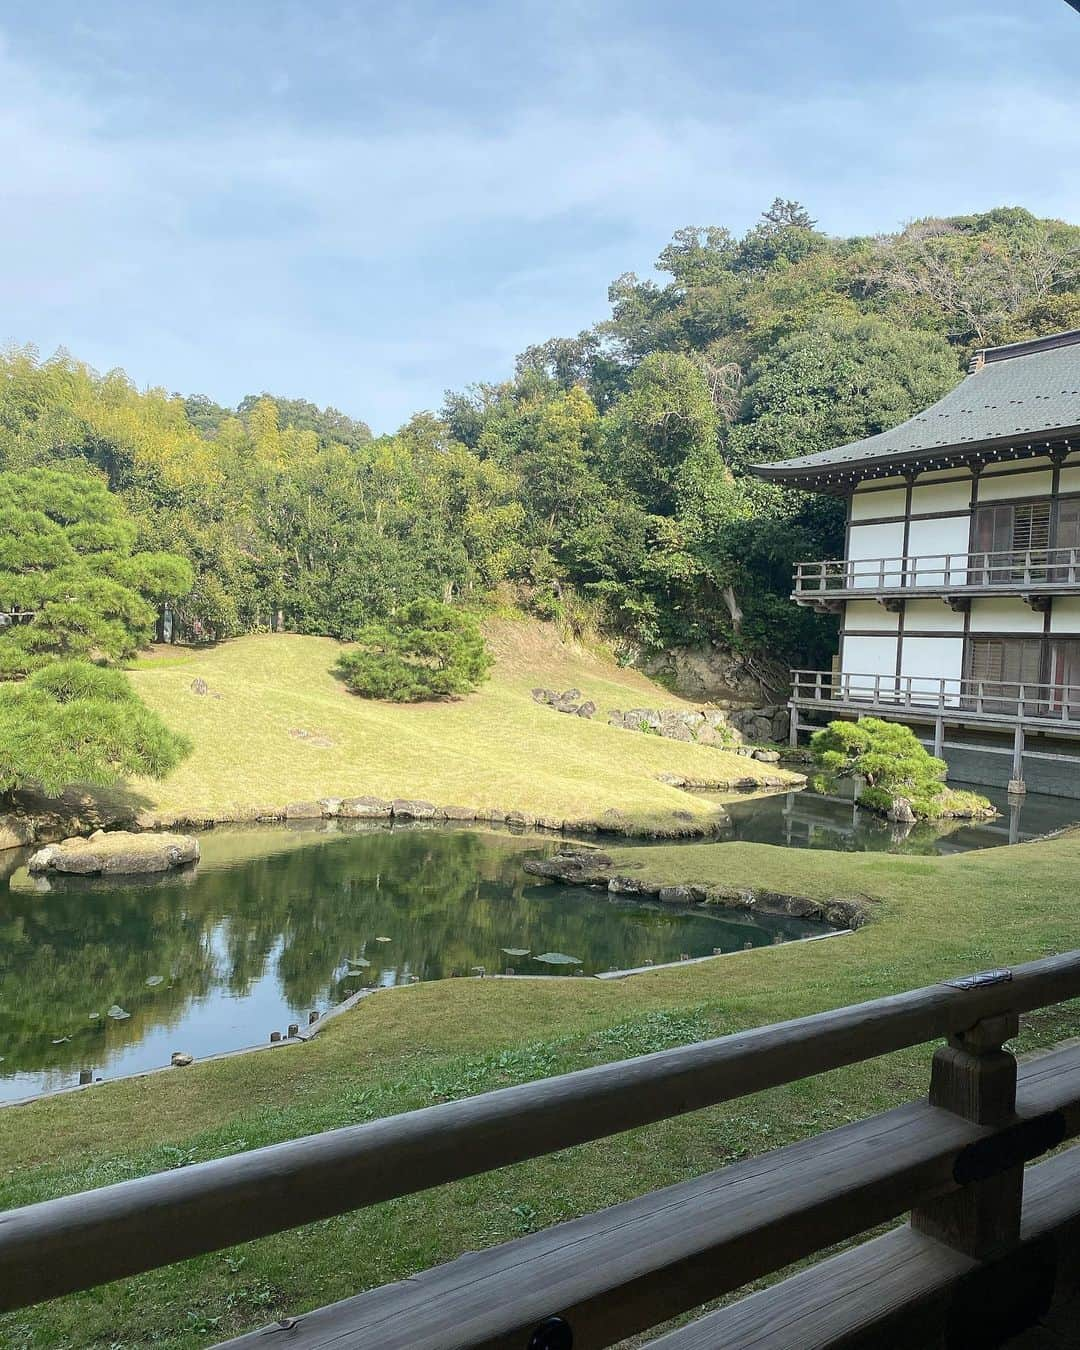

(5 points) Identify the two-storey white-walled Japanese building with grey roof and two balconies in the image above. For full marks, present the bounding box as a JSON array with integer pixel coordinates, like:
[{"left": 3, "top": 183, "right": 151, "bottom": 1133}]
[{"left": 755, "top": 331, "right": 1080, "bottom": 797}]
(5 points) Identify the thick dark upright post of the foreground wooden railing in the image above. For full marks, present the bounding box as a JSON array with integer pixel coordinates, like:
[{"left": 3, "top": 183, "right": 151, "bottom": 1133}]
[{"left": 911, "top": 1013, "right": 1023, "bottom": 1260}]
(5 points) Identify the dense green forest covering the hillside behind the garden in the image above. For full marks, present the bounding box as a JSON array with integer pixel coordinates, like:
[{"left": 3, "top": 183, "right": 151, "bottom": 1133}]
[{"left": 0, "top": 200, "right": 1080, "bottom": 666}]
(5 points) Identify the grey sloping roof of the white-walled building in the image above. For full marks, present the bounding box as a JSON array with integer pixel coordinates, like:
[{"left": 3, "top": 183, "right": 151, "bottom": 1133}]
[{"left": 752, "top": 329, "right": 1080, "bottom": 482}]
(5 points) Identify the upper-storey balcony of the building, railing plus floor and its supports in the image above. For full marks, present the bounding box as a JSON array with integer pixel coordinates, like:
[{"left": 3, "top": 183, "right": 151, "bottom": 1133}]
[{"left": 791, "top": 548, "right": 1080, "bottom": 613}]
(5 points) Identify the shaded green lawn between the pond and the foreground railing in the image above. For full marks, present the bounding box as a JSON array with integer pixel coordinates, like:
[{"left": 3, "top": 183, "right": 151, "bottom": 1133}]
[{"left": 0, "top": 826, "right": 1080, "bottom": 1350}]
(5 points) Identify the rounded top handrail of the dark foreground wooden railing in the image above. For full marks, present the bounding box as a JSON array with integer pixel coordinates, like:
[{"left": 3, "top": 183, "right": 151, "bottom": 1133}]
[{"left": 0, "top": 952, "right": 1080, "bottom": 1310}]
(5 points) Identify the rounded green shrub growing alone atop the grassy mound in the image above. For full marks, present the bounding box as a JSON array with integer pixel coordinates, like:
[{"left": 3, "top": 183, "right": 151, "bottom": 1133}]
[{"left": 336, "top": 599, "right": 491, "bottom": 703}]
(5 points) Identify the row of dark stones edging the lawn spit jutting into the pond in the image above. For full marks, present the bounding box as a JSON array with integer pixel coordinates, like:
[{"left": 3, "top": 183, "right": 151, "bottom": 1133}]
[{"left": 521, "top": 848, "right": 869, "bottom": 929}]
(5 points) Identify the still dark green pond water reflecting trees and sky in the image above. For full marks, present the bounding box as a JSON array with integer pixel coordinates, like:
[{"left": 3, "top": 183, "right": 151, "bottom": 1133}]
[{"left": 0, "top": 792, "right": 1080, "bottom": 1100}]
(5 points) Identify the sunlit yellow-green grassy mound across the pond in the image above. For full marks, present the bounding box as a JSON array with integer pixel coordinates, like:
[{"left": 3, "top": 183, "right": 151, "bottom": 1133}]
[{"left": 122, "top": 621, "right": 793, "bottom": 826}]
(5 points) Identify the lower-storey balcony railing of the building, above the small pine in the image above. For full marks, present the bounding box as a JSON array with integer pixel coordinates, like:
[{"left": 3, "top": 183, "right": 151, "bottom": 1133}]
[{"left": 791, "top": 671, "right": 1080, "bottom": 730}]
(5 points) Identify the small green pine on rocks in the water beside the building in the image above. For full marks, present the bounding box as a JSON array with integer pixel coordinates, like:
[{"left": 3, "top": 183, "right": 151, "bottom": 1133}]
[{"left": 810, "top": 717, "right": 991, "bottom": 819}]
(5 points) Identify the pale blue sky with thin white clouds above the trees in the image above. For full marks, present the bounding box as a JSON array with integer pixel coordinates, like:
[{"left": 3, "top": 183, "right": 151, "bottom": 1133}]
[{"left": 0, "top": 0, "right": 1080, "bottom": 432}]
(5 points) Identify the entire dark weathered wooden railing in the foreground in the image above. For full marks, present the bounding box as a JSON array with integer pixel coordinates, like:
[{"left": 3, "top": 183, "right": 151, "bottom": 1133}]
[{"left": 0, "top": 952, "right": 1080, "bottom": 1350}]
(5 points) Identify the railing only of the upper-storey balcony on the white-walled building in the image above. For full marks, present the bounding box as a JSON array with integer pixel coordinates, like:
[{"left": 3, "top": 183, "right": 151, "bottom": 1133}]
[{"left": 792, "top": 548, "right": 1080, "bottom": 601}]
